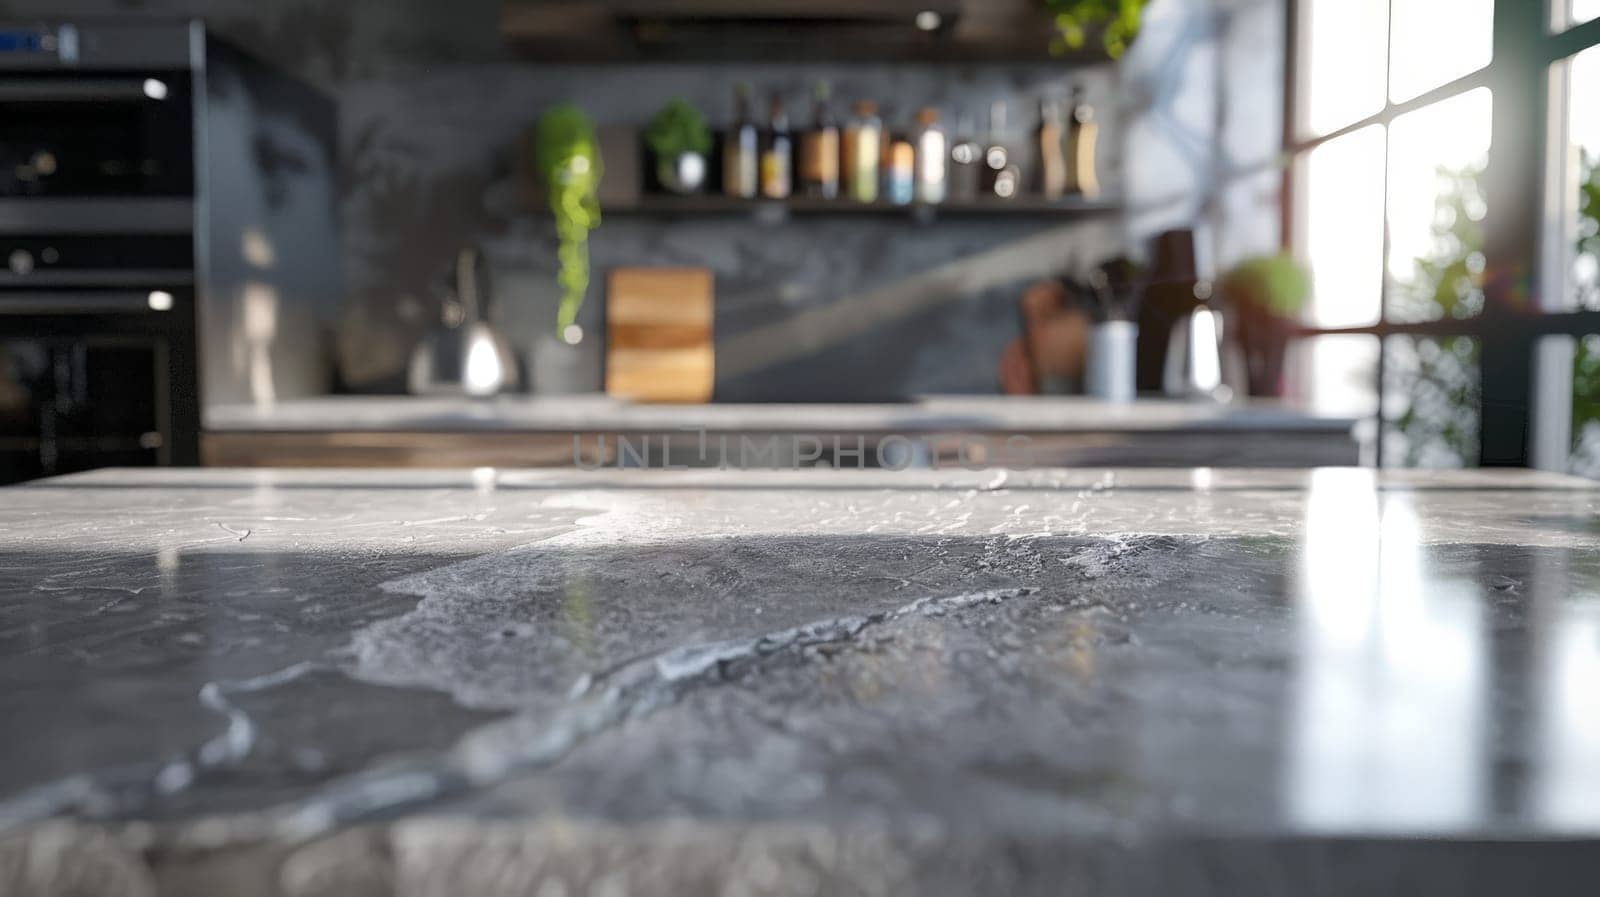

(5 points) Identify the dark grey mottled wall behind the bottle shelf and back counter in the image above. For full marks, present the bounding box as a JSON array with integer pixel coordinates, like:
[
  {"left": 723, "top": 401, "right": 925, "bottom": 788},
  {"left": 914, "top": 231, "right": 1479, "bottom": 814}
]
[{"left": 0, "top": 0, "right": 1283, "bottom": 400}]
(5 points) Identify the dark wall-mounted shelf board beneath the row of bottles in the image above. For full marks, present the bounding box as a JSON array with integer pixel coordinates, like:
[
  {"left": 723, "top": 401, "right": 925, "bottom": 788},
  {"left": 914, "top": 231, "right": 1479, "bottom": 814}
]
[{"left": 602, "top": 193, "right": 1122, "bottom": 221}]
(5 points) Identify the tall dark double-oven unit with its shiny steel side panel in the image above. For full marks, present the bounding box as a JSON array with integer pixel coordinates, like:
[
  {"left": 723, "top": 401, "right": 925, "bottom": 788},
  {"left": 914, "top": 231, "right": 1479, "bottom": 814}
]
[{"left": 0, "top": 22, "right": 342, "bottom": 483}]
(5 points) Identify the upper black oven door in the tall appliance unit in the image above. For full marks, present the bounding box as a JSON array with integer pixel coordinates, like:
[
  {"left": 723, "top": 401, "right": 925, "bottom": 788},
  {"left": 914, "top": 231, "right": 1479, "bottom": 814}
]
[{"left": 0, "top": 70, "right": 194, "bottom": 198}]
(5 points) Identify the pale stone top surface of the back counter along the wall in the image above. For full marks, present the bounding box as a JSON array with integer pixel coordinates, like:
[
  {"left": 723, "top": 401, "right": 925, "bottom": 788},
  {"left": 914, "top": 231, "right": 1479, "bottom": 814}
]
[{"left": 196, "top": 395, "right": 1355, "bottom": 433}]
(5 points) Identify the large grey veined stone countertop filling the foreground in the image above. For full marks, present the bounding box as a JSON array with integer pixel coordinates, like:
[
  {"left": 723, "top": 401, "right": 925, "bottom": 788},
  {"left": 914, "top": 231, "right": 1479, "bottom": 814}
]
[{"left": 0, "top": 468, "right": 1600, "bottom": 895}]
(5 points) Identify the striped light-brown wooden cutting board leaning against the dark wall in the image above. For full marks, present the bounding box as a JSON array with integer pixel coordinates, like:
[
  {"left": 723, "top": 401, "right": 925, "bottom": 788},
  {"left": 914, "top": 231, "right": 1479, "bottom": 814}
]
[{"left": 605, "top": 269, "right": 715, "bottom": 401}]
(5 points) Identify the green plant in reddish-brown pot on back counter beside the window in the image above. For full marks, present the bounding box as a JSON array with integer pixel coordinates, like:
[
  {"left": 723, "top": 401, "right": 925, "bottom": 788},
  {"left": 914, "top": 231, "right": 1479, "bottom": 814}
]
[{"left": 1218, "top": 253, "right": 1310, "bottom": 397}]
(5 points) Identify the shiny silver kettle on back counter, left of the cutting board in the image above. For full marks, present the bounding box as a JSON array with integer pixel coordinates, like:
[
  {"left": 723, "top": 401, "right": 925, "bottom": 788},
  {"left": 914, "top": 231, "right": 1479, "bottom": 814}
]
[{"left": 406, "top": 246, "right": 517, "bottom": 397}]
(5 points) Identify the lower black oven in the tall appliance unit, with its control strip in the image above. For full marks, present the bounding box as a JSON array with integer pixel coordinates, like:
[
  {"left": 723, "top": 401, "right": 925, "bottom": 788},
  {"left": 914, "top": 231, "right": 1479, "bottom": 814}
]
[{"left": 0, "top": 233, "right": 195, "bottom": 483}]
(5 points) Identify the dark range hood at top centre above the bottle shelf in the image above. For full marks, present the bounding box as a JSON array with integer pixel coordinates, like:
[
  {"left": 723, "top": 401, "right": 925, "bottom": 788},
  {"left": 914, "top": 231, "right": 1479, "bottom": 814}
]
[{"left": 501, "top": 0, "right": 1081, "bottom": 62}]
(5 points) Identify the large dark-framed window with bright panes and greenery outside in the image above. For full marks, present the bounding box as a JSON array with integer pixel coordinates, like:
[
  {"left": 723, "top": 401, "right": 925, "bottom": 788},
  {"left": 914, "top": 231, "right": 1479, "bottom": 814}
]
[{"left": 1286, "top": 0, "right": 1600, "bottom": 475}]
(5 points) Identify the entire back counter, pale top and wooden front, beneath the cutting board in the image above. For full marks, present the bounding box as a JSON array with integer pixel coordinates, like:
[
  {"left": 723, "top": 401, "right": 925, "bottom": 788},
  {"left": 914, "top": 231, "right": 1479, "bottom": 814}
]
[{"left": 202, "top": 395, "right": 1373, "bottom": 467}]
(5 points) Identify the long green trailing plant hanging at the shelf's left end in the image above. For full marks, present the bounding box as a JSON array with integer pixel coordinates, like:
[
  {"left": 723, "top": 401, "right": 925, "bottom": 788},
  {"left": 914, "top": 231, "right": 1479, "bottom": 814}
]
[{"left": 533, "top": 104, "right": 603, "bottom": 344}]
